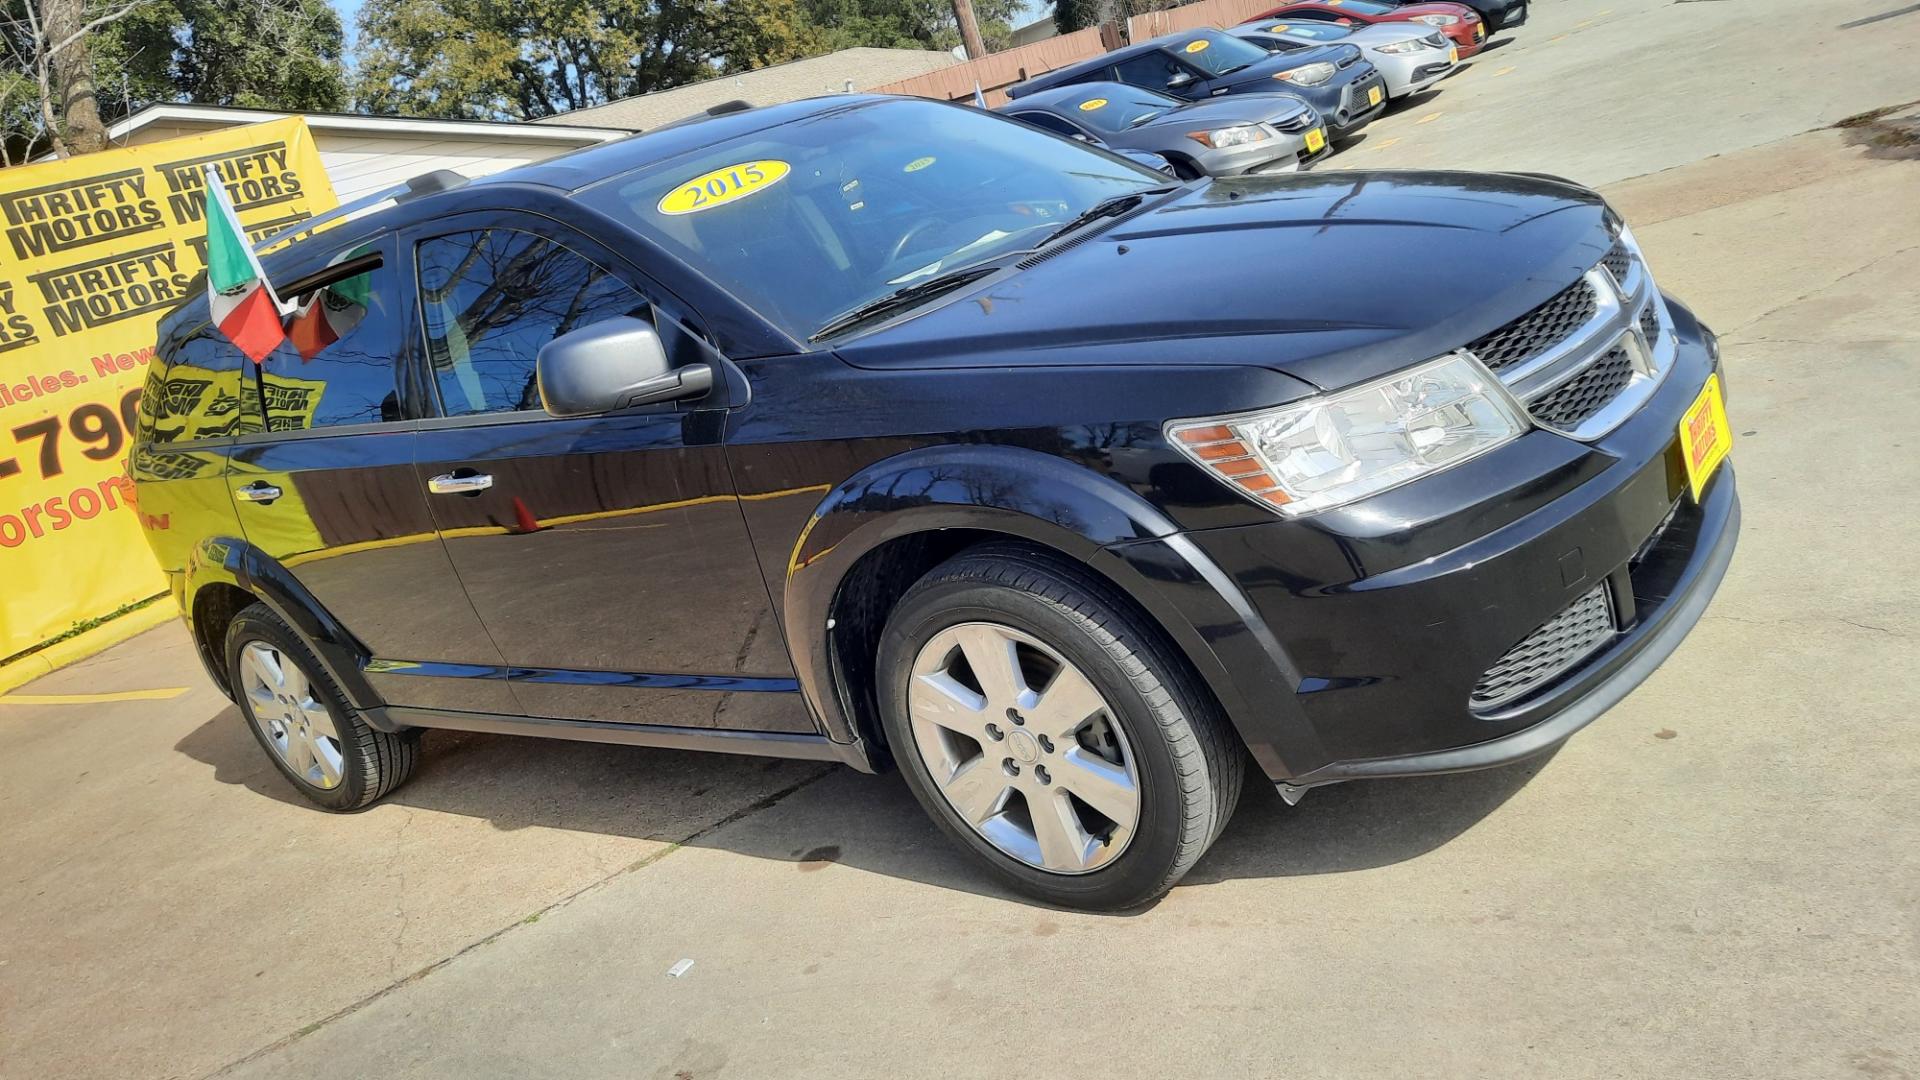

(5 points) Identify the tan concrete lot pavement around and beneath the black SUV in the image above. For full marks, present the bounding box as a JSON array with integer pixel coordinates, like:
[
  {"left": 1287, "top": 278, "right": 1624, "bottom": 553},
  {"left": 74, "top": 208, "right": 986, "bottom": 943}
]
[{"left": 0, "top": 0, "right": 1920, "bottom": 1078}]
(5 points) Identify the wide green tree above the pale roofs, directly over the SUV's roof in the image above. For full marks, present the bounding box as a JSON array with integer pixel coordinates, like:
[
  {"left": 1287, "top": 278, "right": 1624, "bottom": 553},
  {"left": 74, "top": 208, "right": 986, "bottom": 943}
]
[{"left": 355, "top": 0, "right": 826, "bottom": 119}]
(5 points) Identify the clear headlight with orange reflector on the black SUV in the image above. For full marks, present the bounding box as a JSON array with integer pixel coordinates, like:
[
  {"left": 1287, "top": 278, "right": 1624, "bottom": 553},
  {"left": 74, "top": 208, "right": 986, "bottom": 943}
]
[{"left": 1167, "top": 354, "right": 1528, "bottom": 515}]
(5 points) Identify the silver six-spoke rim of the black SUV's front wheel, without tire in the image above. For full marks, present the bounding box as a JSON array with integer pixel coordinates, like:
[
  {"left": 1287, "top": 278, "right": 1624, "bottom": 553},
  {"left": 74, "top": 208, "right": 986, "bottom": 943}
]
[{"left": 906, "top": 623, "right": 1140, "bottom": 874}]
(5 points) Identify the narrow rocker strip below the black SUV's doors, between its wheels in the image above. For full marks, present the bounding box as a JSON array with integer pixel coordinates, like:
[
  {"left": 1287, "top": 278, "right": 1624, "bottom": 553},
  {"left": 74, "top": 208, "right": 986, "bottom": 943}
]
[{"left": 363, "top": 705, "right": 858, "bottom": 763}]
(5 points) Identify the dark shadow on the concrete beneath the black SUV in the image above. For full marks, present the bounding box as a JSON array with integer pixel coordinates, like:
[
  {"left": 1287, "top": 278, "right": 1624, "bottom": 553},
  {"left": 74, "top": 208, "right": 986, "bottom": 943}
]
[{"left": 175, "top": 707, "right": 1551, "bottom": 901}]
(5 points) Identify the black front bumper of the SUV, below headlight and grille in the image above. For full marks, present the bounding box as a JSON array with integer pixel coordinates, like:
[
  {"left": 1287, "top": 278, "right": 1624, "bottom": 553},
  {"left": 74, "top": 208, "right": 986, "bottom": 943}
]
[{"left": 1112, "top": 300, "right": 1740, "bottom": 788}]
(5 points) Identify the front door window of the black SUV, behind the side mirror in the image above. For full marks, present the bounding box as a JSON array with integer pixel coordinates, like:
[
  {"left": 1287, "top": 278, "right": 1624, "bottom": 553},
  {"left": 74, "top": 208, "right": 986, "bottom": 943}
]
[{"left": 419, "top": 229, "right": 651, "bottom": 417}]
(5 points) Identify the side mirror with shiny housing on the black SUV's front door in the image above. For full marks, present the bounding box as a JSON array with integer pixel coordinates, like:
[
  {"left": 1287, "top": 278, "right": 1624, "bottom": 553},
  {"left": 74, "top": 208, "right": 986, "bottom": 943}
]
[{"left": 534, "top": 317, "right": 714, "bottom": 417}]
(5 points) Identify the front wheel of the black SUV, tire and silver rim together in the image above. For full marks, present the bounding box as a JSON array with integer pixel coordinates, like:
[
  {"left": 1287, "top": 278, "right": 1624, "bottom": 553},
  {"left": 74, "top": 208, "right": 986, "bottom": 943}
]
[{"left": 879, "top": 546, "right": 1244, "bottom": 911}]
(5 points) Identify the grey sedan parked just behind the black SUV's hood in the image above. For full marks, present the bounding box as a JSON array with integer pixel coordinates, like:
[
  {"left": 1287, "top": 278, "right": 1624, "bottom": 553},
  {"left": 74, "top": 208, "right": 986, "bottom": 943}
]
[{"left": 998, "top": 83, "right": 1327, "bottom": 179}]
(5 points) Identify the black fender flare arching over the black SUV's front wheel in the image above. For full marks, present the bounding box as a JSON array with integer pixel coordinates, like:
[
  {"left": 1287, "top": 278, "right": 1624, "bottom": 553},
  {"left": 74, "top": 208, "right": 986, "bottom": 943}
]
[{"left": 781, "top": 444, "right": 1282, "bottom": 748}]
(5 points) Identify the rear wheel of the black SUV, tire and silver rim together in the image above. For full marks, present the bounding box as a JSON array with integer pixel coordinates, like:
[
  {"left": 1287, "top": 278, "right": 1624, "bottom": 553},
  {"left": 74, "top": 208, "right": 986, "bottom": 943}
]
[{"left": 227, "top": 603, "right": 420, "bottom": 813}]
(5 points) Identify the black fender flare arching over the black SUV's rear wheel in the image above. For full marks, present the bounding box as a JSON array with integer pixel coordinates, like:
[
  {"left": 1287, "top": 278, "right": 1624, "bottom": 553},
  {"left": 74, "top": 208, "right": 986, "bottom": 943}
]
[{"left": 180, "top": 536, "right": 382, "bottom": 711}]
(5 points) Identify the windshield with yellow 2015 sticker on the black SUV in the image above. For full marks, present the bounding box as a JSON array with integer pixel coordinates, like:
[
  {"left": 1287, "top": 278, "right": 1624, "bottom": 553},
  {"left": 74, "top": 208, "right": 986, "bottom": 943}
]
[{"left": 580, "top": 100, "right": 1167, "bottom": 338}]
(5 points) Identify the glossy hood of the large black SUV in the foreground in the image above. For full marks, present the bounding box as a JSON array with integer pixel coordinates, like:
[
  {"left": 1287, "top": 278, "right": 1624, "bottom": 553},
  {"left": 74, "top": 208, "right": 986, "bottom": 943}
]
[{"left": 835, "top": 171, "right": 1613, "bottom": 388}]
